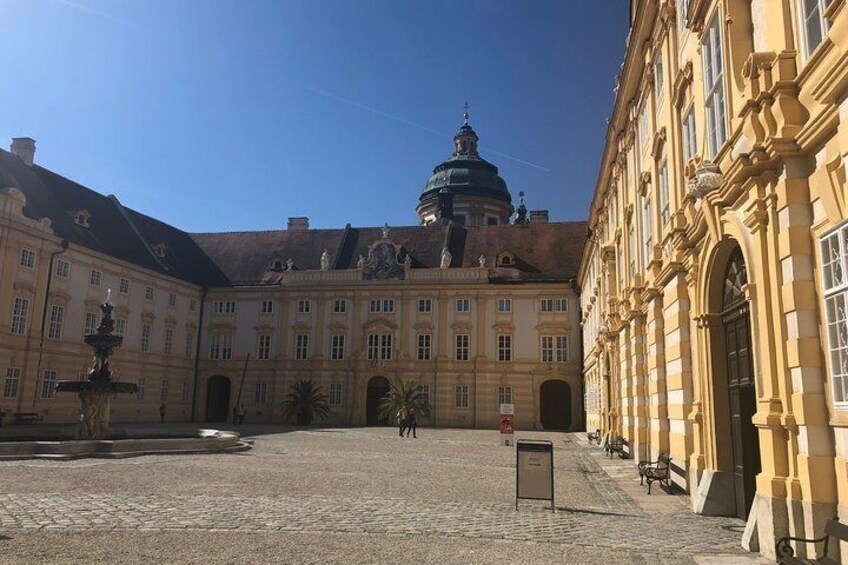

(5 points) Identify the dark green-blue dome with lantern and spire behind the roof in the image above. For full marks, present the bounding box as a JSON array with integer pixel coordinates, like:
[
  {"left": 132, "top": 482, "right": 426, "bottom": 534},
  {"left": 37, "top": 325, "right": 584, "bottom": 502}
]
[{"left": 417, "top": 104, "right": 514, "bottom": 226}]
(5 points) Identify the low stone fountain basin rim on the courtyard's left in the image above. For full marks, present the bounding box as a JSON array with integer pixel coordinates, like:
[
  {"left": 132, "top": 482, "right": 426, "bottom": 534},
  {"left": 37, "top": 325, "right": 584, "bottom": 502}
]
[{"left": 0, "top": 426, "right": 252, "bottom": 461}]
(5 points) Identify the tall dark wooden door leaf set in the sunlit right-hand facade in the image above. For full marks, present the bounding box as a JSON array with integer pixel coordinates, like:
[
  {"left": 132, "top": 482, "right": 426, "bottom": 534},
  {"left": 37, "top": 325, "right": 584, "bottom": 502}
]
[{"left": 722, "top": 252, "right": 761, "bottom": 519}]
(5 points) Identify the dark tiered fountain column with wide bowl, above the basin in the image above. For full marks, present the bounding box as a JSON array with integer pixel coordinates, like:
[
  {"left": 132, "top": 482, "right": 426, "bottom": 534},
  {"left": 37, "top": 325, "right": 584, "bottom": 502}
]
[{"left": 56, "top": 291, "right": 138, "bottom": 440}]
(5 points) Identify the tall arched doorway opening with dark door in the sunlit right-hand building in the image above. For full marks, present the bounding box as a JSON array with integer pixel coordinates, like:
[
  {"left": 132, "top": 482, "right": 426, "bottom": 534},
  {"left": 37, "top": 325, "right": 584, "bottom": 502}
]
[{"left": 712, "top": 246, "right": 761, "bottom": 519}]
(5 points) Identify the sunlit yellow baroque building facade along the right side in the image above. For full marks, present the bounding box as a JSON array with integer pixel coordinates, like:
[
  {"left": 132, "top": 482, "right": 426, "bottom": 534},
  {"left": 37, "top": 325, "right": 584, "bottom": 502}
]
[{"left": 579, "top": 0, "right": 848, "bottom": 557}]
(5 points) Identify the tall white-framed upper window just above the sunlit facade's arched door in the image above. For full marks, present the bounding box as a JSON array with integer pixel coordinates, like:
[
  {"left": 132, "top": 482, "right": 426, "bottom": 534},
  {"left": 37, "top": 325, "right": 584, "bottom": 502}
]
[{"left": 701, "top": 10, "right": 727, "bottom": 158}]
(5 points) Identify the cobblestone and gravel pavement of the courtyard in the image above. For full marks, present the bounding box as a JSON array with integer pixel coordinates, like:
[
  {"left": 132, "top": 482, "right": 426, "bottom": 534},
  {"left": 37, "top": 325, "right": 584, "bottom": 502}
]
[{"left": 0, "top": 428, "right": 768, "bottom": 563}]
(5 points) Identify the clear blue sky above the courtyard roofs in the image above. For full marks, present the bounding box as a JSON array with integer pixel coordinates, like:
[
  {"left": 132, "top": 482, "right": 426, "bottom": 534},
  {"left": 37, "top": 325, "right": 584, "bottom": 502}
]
[{"left": 0, "top": 0, "right": 629, "bottom": 231}]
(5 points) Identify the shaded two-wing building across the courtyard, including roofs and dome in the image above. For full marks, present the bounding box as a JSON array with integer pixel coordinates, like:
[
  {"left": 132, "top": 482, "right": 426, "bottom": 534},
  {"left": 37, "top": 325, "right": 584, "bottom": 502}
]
[{"left": 0, "top": 113, "right": 586, "bottom": 430}]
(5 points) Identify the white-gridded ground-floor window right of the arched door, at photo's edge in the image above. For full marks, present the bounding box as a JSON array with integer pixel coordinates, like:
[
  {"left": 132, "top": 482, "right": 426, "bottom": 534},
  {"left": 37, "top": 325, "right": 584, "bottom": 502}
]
[{"left": 820, "top": 225, "right": 848, "bottom": 409}]
